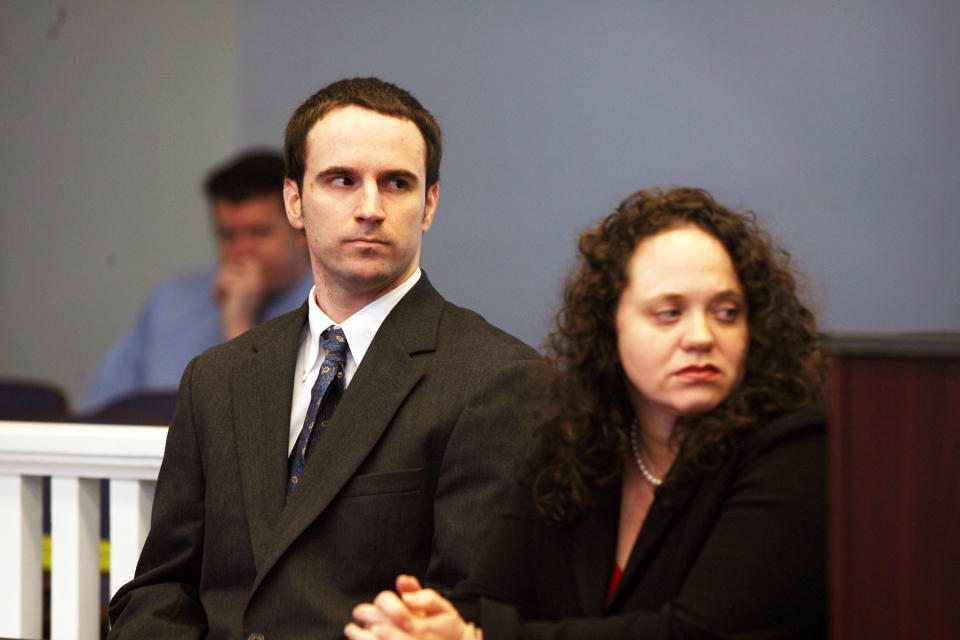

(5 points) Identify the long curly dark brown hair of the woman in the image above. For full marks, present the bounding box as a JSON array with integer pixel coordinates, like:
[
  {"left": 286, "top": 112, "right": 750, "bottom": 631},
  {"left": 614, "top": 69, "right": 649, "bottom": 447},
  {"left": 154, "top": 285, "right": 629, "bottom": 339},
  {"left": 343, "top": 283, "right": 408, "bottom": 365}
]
[{"left": 534, "top": 188, "right": 825, "bottom": 523}]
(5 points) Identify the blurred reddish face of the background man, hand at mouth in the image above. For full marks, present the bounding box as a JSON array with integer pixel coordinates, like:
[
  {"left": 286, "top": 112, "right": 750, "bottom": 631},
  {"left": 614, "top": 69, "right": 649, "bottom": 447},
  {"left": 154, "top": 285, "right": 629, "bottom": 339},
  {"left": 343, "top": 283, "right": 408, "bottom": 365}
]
[{"left": 213, "top": 195, "right": 307, "bottom": 293}]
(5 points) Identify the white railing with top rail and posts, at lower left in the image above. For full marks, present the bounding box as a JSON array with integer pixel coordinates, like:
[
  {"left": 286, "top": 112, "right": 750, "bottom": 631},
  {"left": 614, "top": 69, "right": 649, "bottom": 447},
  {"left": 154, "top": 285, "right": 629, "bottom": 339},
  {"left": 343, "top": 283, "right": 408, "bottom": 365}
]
[{"left": 0, "top": 421, "right": 167, "bottom": 640}]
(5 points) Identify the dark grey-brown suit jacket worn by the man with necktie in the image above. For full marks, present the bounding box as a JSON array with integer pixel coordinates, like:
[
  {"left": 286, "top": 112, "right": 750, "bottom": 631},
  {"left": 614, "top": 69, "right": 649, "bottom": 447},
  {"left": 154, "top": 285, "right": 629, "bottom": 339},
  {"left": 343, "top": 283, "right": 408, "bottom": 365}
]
[{"left": 110, "top": 276, "right": 541, "bottom": 640}]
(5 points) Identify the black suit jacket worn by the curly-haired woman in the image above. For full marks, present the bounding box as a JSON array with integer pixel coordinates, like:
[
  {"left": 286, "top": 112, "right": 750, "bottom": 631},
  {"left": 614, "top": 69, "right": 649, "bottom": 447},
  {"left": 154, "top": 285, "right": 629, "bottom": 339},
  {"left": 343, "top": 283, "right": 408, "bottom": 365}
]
[{"left": 454, "top": 408, "right": 826, "bottom": 640}]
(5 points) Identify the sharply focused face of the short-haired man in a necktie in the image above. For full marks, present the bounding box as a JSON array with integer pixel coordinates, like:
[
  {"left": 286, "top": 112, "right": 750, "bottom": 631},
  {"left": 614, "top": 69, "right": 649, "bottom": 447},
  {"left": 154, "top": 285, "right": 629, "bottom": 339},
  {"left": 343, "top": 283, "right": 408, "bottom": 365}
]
[{"left": 284, "top": 105, "right": 438, "bottom": 306}]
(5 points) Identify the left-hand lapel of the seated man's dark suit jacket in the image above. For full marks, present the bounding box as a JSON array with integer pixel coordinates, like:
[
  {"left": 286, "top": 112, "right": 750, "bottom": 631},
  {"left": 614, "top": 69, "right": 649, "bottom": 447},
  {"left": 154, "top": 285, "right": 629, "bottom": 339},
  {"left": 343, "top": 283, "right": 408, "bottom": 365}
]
[{"left": 232, "top": 305, "right": 306, "bottom": 567}]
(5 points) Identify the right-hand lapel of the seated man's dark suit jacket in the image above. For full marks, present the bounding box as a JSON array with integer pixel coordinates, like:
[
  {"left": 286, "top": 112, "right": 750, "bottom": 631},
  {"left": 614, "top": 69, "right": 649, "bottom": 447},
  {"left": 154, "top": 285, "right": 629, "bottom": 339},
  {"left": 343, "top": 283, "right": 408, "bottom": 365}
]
[{"left": 253, "top": 275, "right": 444, "bottom": 589}]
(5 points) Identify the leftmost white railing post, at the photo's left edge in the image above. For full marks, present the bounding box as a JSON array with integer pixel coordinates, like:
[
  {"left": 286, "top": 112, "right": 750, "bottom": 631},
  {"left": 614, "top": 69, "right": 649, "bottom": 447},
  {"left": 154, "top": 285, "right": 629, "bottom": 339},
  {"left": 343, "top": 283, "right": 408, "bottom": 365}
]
[{"left": 0, "top": 475, "right": 43, "bottom": 638}]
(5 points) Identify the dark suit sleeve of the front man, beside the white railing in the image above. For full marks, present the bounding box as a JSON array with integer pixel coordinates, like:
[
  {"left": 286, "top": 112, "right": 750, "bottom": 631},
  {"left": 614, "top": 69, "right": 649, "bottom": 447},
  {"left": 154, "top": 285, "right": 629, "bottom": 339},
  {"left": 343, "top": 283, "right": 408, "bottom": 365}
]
[{"left": 108, "top": 359, "right": 207, "bottom": 639}]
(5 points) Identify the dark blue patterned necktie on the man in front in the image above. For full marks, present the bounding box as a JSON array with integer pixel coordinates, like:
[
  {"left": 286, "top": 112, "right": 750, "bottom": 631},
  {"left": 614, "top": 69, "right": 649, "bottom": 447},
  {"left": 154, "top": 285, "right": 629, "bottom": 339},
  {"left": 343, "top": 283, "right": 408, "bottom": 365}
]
[{"left": 287, "top": 327, "right": 348, "bottom": 498}]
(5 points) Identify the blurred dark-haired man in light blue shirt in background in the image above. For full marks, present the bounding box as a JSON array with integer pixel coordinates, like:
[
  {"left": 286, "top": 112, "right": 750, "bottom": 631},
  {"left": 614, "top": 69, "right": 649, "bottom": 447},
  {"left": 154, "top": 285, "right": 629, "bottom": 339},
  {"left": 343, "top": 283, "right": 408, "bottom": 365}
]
[{"left": 79, "top": 151, "right": 313, "bottom": 413}]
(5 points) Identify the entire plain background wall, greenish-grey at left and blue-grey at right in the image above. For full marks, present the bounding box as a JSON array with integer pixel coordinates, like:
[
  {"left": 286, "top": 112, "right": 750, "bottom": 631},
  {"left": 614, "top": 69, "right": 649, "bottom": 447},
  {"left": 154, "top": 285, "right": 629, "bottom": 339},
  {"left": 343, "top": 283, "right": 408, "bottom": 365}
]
[{"left": 0, "top": 0, "right": 960, "bottom": 404}]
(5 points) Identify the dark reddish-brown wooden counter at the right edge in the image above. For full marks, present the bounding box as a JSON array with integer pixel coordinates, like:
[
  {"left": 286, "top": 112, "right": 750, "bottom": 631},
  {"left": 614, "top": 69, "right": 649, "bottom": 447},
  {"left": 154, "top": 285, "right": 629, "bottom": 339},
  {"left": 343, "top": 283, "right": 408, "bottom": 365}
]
[{"left": 826, "top": 334, "right": 960, "bottom": 640}]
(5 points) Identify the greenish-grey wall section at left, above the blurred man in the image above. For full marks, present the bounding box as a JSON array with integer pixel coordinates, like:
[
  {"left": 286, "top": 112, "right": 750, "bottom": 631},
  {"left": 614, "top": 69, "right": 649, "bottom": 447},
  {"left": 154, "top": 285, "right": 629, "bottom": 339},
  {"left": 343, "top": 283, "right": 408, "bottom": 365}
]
[{"left": 0, "top": 0, "right": 238, "bottom": 397}]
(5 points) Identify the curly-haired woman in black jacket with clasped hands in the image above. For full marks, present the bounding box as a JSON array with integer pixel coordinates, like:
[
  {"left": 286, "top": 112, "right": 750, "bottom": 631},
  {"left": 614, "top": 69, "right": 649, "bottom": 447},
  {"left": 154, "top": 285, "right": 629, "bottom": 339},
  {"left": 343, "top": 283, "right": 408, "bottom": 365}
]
[{"left": 346, "top": 188, "right": 826, "bottom": 640}]
